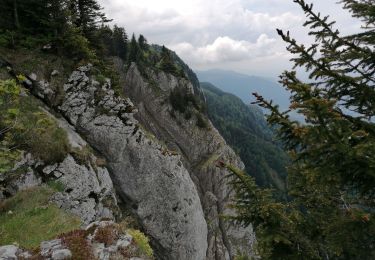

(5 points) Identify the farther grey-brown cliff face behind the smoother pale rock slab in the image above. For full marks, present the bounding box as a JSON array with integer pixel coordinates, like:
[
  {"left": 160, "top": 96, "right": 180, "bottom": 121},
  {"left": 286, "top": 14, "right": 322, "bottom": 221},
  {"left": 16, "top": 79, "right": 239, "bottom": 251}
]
[{"left": 123, "top": 64, "right": 255, "bottom": 259}]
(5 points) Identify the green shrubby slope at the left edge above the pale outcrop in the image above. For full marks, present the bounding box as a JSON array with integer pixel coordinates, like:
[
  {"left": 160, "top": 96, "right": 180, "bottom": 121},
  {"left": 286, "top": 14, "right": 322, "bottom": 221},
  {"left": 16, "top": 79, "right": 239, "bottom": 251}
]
[{"left": 0, "top": 80, "right": 69, "bottom": 167}]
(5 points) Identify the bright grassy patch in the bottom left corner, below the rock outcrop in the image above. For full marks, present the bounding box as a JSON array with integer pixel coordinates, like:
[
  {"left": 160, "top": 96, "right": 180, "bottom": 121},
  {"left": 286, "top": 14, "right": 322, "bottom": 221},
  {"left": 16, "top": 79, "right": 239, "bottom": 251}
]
[{"left": 0, "top": 187, "right": 80, "bottom": 249}]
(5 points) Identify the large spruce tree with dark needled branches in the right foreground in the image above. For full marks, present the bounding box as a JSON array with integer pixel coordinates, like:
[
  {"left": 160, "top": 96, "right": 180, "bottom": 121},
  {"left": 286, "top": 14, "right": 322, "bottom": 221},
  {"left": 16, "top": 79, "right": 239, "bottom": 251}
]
[{"left": 230, "top": 0, "right": 375, "bottom": 259}]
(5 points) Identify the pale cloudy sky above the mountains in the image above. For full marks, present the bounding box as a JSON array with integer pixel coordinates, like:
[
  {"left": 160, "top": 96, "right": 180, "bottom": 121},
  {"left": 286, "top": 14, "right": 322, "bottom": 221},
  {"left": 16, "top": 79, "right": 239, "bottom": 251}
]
[{"left": 99, "top": 0, "right": 360, "bottom": 78}]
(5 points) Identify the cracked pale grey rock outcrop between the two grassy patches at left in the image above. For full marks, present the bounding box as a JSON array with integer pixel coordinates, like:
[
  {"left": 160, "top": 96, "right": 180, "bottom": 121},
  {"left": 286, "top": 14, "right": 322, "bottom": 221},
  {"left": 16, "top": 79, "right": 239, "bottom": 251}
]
[{"left": 0, "top": 110, "right": 119, "bottom": 225}]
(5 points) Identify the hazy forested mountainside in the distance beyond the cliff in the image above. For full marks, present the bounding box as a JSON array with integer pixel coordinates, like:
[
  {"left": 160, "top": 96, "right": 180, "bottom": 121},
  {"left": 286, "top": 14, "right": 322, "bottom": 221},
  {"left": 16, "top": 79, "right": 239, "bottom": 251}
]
[{"left": 201, "top": 83, "right": 288, "bottom": 192}]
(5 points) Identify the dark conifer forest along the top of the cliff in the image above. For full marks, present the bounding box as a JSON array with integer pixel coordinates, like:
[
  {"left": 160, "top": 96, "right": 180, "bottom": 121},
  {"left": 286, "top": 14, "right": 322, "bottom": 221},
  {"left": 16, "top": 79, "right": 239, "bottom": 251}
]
[{"left": 0, "top": 0, "right": 188, "bottom": 84}]
